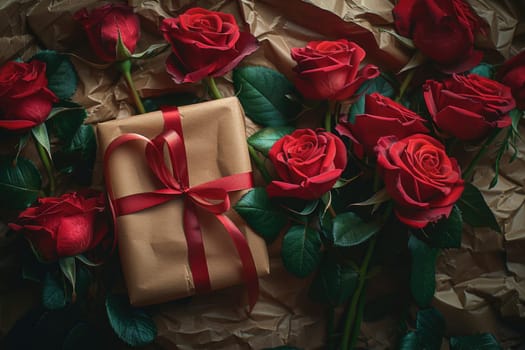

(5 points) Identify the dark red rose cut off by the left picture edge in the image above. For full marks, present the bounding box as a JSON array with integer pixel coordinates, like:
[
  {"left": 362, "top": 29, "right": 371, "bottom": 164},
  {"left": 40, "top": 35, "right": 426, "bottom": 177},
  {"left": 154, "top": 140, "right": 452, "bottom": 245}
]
[{"left": 0, "top": 60, "right": 58, "bottom": 130}]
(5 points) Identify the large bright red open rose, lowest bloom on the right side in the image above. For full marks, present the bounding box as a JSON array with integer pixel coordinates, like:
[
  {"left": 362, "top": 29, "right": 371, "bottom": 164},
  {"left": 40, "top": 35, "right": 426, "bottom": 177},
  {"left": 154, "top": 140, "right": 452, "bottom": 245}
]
[{"left": 376, "top": 134, "right": 465, "bottom": 228}]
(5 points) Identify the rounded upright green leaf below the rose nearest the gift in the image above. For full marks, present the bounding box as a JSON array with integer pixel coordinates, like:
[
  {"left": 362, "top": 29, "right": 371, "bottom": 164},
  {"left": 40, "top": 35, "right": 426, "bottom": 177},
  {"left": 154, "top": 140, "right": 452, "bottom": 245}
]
[{"left": 281, "top": 225, "right": 322, "bottom": 277}]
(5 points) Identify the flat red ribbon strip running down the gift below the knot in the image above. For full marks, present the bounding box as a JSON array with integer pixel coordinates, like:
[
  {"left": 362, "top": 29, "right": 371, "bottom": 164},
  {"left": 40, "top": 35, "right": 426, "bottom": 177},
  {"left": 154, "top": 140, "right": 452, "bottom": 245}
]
[{"left": 184, "top": 197, "right": 211, "bottom": 293}]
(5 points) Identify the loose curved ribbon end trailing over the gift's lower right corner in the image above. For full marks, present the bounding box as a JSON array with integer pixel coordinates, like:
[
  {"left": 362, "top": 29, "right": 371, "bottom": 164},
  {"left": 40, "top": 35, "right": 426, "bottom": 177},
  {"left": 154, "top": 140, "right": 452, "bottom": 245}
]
[{"left": 215, "top": 215, "right": 259, "bottom": 312}]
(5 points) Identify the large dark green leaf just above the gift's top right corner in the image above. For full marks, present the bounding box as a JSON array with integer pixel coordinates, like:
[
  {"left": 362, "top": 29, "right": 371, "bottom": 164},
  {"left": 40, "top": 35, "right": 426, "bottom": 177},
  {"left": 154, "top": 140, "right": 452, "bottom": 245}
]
[{"left": 233, "top": 66, "right": 301, "bottom": 126}]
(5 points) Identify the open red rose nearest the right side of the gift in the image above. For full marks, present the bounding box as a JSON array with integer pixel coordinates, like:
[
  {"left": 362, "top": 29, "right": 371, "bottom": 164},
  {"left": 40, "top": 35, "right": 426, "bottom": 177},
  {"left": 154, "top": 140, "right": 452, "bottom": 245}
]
[{"left": 266, "top": 129, "right": 346, "bottom": 199}]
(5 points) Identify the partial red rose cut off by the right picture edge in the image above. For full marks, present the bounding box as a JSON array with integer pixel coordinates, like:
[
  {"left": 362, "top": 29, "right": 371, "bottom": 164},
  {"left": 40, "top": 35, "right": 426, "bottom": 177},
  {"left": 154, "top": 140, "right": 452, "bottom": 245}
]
[{"left": 497, "top": 51, "right": 525, "bottom": 109}]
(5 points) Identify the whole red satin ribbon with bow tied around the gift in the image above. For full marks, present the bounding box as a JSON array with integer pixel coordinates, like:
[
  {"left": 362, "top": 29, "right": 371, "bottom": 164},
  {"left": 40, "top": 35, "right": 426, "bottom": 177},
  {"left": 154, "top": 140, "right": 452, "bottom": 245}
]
[{"left": 104, "top": 108, "right": 259, "bottom": 309}]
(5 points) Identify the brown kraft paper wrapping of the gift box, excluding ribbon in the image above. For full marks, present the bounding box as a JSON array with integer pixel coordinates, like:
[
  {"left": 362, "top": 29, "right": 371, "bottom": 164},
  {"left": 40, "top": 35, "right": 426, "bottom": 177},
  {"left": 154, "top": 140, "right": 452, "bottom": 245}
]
[{"left": 97, "top": 97, "right": 269, "bottom": 305}]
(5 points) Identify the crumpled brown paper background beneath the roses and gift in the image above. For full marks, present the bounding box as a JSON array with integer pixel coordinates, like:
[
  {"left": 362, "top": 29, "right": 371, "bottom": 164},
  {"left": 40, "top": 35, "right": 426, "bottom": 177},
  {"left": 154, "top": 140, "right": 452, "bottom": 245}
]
[{"left": 0, "top": 0, "right": 525, "bottom": 349}]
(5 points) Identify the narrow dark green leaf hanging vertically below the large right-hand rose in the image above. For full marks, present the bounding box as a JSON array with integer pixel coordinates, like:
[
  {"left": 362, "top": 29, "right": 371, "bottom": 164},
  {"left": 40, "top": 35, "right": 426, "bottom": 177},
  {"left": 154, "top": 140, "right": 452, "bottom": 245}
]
[{"left": 408, "top": 235, "right": 439, "bottom": 307}]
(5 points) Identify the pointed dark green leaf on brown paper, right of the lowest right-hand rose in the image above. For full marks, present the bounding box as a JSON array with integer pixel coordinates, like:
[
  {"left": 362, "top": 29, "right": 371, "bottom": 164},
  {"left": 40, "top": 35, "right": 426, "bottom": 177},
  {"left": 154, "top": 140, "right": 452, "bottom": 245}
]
[{"left": 457, "top": 183, "right": 501, "bottom": 232}]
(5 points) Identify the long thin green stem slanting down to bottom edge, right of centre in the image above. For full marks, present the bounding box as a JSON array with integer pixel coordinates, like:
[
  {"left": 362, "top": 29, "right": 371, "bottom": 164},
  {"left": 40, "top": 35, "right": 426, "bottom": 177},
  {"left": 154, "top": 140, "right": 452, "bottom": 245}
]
[{"left": 341, "top": 236, "right": 376, "bottom": 350}]
